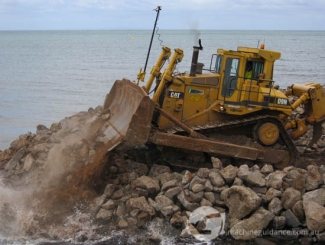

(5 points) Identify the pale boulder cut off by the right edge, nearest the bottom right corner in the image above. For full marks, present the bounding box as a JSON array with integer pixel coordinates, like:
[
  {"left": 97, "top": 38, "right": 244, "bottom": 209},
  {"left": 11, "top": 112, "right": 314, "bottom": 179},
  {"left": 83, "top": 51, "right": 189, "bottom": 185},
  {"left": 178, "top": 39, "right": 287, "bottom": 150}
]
[{"left": 303, "top": 201, "right": 325, "bottom": 232}]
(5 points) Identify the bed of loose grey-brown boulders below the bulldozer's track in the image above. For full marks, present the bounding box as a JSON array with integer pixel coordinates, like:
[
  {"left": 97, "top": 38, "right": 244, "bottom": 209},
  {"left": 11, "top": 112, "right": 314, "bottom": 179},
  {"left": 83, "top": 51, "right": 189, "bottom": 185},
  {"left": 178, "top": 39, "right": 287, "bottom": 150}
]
[{"left": 92, "top": 154, "right": 325, "bottom": 242}]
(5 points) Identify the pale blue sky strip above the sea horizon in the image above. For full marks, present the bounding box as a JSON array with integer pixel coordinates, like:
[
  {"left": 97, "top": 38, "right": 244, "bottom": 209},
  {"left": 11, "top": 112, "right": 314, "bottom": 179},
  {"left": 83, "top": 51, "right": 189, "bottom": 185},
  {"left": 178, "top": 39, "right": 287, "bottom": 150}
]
[{"left": 0, "top": 0, "right": 325, "bottom": 30}]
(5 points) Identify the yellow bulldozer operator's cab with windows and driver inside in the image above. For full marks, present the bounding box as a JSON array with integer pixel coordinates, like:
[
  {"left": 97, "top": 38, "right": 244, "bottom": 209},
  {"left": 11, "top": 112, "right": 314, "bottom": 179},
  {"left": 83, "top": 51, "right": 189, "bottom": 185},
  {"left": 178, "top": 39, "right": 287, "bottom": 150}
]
[{"left": 215, "top": 47, "right": 287, "bottom": 115}]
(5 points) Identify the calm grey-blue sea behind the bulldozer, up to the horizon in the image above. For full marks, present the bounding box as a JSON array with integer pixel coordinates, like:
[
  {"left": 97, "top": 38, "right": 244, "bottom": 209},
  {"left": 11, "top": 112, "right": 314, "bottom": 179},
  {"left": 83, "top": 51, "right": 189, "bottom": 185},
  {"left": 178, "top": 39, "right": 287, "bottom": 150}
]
[{"left": 0, "top": 30, "right": 325, "bottom": 150}]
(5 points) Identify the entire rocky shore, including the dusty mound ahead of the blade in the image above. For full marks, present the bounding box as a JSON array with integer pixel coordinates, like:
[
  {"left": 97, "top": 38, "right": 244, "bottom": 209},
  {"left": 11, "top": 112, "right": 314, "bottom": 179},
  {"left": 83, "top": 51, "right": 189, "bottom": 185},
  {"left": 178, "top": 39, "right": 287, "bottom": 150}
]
[{"left": 0, "top": 107, "right": 325, "bottom": 244}]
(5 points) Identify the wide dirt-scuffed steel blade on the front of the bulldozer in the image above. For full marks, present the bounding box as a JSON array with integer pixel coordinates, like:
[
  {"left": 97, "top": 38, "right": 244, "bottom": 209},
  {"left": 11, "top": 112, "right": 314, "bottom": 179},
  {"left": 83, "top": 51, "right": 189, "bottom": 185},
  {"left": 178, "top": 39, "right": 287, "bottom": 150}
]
[{"left": 103, "top": 79, "right": 155, "bottom": 150}]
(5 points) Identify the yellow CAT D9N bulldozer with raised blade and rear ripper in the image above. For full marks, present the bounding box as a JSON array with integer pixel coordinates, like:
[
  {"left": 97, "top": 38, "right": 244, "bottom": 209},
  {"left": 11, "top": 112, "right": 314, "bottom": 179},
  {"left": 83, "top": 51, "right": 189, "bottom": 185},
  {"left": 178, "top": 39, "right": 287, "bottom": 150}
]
[{"left": 104, "top": 41, "right": 325, "bottom": 168}]
